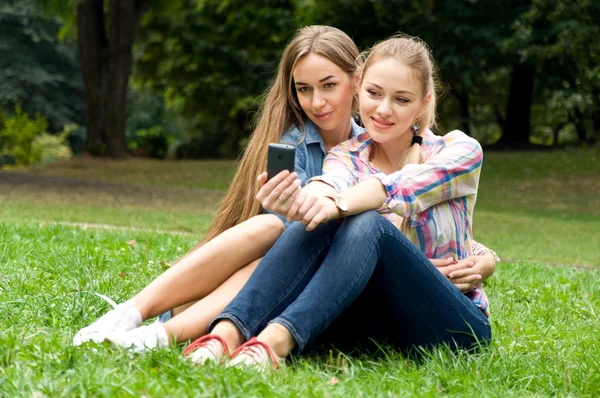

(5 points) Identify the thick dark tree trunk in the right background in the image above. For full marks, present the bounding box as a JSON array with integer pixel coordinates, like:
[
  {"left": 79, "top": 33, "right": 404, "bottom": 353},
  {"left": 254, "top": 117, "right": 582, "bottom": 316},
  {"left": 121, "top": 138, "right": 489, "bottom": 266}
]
[{"left": 497, "top": 64, "right": 535, "bottom": 148}]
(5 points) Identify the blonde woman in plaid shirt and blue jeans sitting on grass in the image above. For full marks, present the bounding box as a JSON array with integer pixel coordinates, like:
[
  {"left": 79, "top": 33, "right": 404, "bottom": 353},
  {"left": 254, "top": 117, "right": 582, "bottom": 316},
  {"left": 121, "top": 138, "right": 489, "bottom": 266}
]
[{"left": 187, "top": 36, "right": 491, "bottom": 369}]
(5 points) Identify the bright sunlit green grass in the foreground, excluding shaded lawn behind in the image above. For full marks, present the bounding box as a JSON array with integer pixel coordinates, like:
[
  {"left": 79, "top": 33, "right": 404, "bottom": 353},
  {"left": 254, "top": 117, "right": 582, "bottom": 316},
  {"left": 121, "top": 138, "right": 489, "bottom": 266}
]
[{"left": 0, "top": 222, "right": 600, "bottom": 397}]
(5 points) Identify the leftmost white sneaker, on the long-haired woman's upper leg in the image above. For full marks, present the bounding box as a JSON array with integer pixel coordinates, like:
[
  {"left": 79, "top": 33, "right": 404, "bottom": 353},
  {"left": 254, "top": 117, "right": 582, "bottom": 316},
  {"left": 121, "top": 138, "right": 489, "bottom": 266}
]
[{"left": 73, "top": 300, "right": 142, "bottom": 346}]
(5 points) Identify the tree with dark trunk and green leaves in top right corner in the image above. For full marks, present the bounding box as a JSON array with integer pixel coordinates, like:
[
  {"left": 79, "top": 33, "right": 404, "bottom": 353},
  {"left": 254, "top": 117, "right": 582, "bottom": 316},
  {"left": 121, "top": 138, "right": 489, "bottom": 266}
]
[{"left": 500, "top": 0, "right": 600, "bottom": 146}]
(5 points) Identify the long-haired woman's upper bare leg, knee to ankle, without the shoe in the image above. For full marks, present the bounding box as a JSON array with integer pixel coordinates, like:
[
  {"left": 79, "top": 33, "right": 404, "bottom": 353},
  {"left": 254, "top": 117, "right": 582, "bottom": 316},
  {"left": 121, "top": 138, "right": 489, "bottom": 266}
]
[{"left": 133, "top": 214, "right": 284, "bottom": 320}]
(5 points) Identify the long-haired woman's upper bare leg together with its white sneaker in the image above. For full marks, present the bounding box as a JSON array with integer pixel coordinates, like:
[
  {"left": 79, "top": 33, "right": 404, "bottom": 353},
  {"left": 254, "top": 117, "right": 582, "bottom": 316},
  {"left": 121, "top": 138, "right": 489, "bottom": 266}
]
[{"left": 73, "top": 215, "right": 284, "bottom": 346}]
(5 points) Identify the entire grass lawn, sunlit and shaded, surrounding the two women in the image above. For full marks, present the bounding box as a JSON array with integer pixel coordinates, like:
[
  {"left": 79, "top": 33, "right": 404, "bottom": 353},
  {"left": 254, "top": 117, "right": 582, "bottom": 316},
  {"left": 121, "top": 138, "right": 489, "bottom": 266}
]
[{"left": 0, "top": 151, "right": 600, "bottom": 397}]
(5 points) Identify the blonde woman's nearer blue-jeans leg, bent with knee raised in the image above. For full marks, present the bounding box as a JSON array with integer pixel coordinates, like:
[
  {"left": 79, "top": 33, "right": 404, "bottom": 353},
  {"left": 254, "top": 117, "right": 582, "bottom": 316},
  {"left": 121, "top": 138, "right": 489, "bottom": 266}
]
[{"left": 265, "top": 212, "right": 491, "bottom": 351}]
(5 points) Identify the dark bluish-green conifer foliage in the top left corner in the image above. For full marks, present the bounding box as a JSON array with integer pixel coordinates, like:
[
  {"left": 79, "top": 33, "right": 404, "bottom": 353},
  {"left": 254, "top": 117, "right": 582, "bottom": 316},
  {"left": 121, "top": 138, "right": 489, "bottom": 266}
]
[{"left": 0, "top": 0, "right": 84, "bottom": 131}]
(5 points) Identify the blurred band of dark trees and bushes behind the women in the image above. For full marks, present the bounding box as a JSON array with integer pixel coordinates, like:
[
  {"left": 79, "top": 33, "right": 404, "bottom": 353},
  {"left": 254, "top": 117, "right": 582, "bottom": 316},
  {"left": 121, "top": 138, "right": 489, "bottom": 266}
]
[{"left": 0, "top": 0, "right": 600, "bottom": 165}]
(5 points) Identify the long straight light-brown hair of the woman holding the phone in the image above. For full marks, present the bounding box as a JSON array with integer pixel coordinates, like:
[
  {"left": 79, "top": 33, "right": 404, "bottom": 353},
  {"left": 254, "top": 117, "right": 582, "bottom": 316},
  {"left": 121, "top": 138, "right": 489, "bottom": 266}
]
[{"left": 176, "top": 25, "right": 358, "bottom": 262}]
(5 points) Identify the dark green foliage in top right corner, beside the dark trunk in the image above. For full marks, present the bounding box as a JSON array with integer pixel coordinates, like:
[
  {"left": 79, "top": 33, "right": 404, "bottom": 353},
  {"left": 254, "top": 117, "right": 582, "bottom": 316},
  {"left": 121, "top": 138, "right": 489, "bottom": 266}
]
[{"left": 506, "top": 0, "right": 600, "bottom": 141}]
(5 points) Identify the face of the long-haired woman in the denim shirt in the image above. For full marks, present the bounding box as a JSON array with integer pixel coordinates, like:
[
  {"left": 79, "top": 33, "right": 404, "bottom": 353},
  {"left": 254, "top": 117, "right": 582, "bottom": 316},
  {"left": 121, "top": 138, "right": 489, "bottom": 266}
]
[{"left": 292, "top": 53, "right": 353, "bottom": 139}]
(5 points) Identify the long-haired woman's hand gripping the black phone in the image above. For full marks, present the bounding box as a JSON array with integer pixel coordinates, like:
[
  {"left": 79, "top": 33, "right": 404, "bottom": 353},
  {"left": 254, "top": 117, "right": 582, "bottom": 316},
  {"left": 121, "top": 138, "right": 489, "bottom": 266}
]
[{"left": 256, "top": 170, "right": 301, "bottom": 216}]
